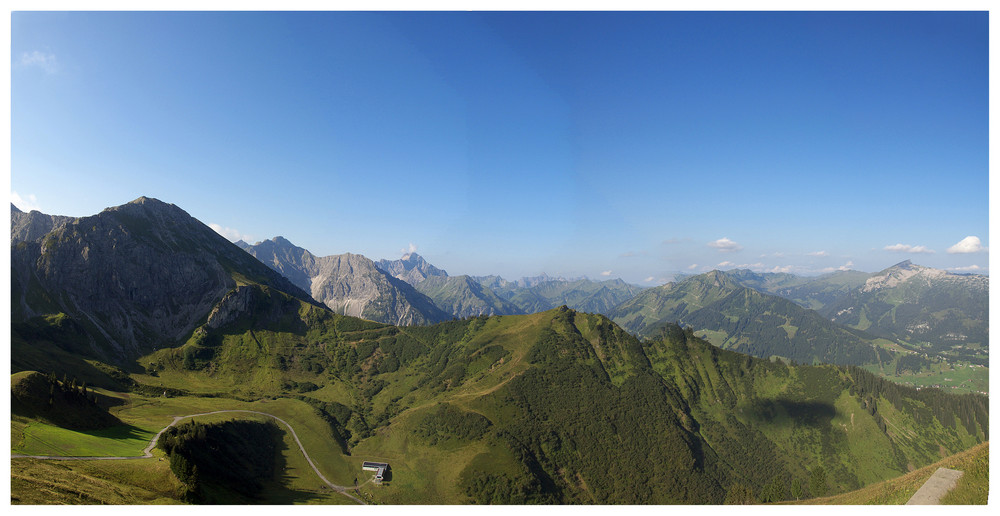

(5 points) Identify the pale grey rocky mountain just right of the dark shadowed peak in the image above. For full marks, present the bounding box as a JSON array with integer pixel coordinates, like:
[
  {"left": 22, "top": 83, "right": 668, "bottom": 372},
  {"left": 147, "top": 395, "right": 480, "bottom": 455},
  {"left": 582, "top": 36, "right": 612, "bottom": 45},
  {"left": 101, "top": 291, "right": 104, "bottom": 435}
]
[{"left": 246, "top": 236, "right": 451, "bottom": 326}]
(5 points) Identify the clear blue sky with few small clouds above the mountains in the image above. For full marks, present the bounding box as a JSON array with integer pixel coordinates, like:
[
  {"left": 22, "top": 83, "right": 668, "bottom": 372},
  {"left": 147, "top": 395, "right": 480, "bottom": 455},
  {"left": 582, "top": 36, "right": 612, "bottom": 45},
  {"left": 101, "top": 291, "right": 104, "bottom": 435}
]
[{"left": 11, "top": 12, "right": 989, "bottom": 285}]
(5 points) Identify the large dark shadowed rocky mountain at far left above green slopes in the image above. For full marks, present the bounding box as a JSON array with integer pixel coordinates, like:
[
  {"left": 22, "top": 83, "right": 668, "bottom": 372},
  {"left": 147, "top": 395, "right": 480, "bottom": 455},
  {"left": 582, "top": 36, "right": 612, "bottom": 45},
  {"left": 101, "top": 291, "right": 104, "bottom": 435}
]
[{"left": 11, "top": 197, "right": 313, "bottom": 362}]
